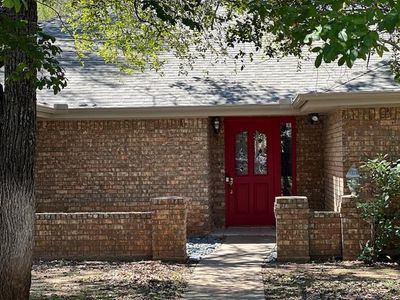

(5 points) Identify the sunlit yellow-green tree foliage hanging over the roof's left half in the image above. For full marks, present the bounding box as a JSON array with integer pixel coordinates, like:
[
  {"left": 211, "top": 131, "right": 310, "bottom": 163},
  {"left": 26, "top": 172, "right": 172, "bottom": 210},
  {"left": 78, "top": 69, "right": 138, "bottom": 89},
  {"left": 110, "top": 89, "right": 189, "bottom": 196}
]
[{"left": 66, "top": 0, "right": 222, "bottom": 73}]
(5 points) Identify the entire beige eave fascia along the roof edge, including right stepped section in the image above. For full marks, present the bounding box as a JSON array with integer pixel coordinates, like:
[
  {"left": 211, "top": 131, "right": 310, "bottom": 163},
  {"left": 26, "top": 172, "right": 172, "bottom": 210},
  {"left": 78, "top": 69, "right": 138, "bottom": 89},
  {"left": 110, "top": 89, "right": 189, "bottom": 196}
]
[{"left": 37, "top": 91, "right": 400, "bottom": 120}]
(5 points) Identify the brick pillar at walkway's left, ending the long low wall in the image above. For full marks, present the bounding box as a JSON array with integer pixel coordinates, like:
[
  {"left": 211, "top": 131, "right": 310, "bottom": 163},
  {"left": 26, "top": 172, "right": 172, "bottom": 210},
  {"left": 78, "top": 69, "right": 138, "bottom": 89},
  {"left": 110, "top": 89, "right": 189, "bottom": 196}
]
[{"left": 151, "top": 197, "right": 187, "bottom": 260}]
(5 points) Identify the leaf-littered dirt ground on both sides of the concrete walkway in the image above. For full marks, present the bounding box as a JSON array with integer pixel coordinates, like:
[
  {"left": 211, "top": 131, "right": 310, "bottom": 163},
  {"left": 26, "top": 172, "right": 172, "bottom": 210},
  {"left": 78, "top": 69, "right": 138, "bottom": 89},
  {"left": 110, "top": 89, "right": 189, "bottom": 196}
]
[{"left": 31, "top": 260, "right": 400, "bottom": 300}]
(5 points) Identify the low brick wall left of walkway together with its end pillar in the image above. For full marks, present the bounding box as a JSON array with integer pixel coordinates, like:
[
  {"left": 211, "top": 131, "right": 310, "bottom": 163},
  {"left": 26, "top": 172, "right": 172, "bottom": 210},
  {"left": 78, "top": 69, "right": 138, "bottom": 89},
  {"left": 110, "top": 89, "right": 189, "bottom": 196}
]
[{"left": 34, "top": 197, "right": 188, "bottom": 260}]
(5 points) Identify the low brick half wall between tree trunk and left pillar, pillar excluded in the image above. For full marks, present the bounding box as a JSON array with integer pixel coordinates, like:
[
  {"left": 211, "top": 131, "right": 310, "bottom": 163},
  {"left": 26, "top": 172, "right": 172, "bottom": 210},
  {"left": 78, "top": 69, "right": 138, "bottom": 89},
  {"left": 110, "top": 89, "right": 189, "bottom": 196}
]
[{"left": 34, "top": 212, "right": 152, "bottom": 259}]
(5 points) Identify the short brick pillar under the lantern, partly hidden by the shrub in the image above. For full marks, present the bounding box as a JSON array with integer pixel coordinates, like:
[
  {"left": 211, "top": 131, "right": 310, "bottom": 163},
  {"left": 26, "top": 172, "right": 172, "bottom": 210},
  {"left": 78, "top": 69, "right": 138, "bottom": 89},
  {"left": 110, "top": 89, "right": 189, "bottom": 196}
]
[{"left": 340, "top": 195, "right": 371, "bottom": 260}]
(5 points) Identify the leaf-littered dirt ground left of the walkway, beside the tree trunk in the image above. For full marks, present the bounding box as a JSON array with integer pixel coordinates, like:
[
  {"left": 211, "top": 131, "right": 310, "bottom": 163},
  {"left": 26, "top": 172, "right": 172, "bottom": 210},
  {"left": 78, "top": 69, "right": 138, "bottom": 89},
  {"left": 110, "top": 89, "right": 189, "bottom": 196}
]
[{"left": 31, "top": 260, "right": 190, "bottom": 300}]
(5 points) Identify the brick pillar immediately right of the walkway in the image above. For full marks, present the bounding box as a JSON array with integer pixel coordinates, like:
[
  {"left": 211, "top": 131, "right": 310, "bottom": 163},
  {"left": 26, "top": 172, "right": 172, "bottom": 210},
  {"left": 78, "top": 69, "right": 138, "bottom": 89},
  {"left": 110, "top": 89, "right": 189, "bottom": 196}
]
[{"left": 275, "top": 196, "right": 310, "bottom": 261}]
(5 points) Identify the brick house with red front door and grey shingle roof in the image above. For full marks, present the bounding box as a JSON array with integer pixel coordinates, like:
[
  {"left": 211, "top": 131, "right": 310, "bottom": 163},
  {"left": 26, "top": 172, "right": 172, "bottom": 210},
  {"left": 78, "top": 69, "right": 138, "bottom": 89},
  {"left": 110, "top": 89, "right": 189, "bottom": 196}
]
[{"left": 31, "top": 20, "right": 400, "bottom": 241}]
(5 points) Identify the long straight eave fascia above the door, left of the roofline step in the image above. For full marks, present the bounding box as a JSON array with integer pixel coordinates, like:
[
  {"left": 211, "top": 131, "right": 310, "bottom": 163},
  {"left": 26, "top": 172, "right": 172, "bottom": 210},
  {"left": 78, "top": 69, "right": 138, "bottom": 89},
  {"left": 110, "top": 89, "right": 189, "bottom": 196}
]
[{"left": 38, "top": 104, "right": 299, "bottom": 120}]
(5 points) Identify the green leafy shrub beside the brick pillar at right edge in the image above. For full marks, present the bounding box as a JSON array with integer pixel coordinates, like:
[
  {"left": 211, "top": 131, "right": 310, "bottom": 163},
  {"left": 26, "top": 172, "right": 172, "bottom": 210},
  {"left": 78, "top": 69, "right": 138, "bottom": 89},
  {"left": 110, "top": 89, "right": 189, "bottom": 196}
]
[{"left": 357, "top": 156, "right": 400, "bottom": 261}]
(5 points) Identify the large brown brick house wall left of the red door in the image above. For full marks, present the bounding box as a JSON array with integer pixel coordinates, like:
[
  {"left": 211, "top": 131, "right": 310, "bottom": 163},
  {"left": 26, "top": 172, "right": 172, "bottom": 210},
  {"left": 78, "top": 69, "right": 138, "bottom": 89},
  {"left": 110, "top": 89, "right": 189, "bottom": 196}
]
[{"left": 36, "top": 118, "right": 210, "bottom": 233}]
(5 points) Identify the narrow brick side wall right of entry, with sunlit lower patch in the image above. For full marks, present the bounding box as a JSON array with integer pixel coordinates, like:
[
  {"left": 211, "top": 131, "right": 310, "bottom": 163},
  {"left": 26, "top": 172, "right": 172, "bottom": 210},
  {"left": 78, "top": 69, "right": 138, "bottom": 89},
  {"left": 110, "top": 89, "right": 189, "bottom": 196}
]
[{"left": 324, "top": 111, "right": 344, "bottom": 211}]
